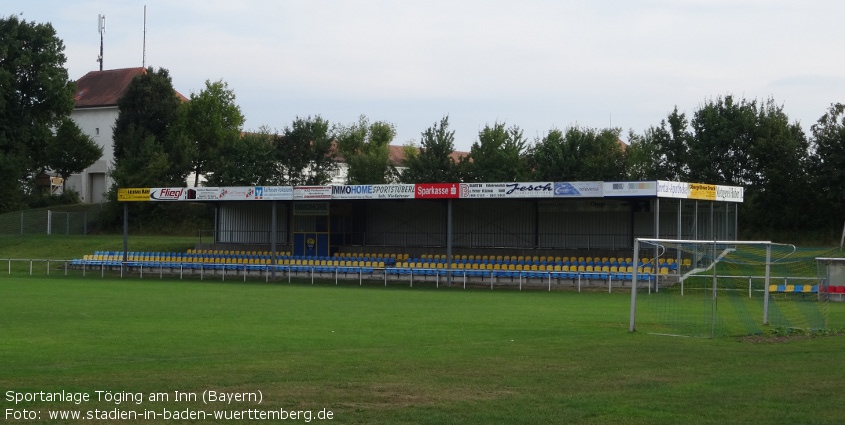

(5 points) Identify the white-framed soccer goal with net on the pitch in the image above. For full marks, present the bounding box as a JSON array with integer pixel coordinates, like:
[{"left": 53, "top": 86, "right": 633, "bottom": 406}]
[{"left": 630, "top": 239, "right": 827, "bottom": 338}]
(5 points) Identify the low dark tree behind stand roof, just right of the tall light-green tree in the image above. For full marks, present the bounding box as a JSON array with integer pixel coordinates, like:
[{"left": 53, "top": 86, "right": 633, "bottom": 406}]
[{"left": 206, "top": 127, "right": 279, "bottom": 186}]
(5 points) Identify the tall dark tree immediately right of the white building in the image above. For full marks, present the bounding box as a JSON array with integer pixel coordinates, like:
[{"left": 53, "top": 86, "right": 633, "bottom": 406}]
[{"left": 112, "top": 68, "right": 191, "bottom": 187}]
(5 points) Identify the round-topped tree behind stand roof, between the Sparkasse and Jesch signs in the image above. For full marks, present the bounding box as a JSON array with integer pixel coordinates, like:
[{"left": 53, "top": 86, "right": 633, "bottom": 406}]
[{"left": 460, "top": 122, "right": 529, "bottom": 182}]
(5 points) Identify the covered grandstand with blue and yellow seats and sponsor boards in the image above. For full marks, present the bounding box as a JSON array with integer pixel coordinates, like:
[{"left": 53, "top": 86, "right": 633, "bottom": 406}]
[{"left": 87, "top": 177, "right": 742, "bottom": 288}]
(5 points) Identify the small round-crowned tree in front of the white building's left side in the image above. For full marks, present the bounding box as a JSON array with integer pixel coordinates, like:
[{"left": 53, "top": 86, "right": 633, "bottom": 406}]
[{"left": 46, "top": 118, "right": 103, "bottom": 193}]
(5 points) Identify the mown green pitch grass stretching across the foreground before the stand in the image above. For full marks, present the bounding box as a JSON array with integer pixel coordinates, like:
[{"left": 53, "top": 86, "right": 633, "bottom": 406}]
[{"left": 0, "top": 275, "right": 845, "bottom": 424}]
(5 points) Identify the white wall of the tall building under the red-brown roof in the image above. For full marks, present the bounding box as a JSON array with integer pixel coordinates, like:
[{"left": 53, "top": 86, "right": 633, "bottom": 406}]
[{"left": 67, "top": 106, "right": 119, "bottom": 203}]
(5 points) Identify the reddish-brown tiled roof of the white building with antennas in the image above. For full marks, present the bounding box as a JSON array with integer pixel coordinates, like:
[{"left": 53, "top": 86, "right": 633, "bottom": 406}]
[{"left": 74, "top": 67, "right": 188, "bottom": 108}]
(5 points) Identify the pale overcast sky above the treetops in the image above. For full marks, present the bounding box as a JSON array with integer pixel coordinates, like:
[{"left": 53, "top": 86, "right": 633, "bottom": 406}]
[{"left": 8, "top": 0, "right": 845, "bottom": 151}]
